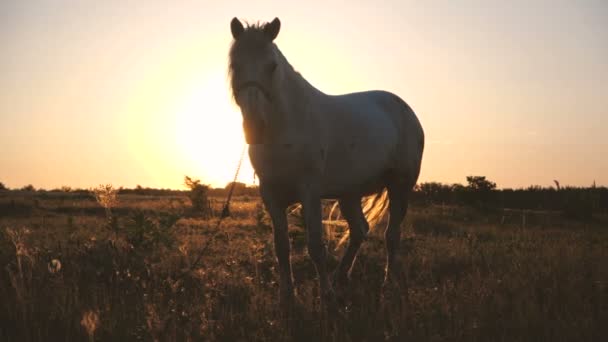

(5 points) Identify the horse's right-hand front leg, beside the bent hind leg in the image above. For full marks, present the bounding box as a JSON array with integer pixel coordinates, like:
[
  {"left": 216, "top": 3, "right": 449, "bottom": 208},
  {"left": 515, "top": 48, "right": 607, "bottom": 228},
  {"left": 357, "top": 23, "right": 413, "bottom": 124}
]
[{"left": 301, "top": 186, "right": 335, "bottom": 305}]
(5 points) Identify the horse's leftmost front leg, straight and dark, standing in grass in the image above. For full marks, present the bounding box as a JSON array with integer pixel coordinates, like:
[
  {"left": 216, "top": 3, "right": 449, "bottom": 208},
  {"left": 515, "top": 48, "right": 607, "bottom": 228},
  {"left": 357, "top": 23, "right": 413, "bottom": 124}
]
[{"left": 261, "top": 188, "right": 295, "bottom": 312}]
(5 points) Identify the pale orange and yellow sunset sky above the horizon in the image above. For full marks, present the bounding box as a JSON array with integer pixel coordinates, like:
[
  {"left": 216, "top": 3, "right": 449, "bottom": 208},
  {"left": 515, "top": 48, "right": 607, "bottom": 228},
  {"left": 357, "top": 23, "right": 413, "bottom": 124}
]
[{"left": 0, "top": 0, "right": 608, "bottom": 189}]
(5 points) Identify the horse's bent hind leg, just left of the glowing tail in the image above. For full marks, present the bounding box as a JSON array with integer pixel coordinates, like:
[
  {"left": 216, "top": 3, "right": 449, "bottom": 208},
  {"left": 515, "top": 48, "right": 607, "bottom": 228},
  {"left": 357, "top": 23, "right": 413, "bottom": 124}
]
[{"left": 334, "top": 197, "right": 369, "bottom": 288}]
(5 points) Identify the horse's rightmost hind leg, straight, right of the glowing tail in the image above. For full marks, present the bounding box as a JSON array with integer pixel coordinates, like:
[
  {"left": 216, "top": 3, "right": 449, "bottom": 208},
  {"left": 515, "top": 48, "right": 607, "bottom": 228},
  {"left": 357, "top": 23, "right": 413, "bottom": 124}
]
[{"left": 384, "top": 185, "right": 411, "bottom": 283}]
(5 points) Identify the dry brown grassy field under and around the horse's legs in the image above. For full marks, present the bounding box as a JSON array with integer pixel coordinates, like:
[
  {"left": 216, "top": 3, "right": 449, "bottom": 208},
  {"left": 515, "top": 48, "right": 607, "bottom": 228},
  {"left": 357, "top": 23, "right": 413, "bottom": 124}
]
[{"left": 0, "top": 191, "right": 608, "bottom": 341}]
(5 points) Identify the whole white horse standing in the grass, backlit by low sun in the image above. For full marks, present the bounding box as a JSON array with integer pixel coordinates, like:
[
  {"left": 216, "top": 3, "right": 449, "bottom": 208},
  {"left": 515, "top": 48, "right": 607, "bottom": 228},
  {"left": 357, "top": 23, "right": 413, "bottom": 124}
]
[{"left": 229, "top": 18, "right": 424, "bottom": 306}]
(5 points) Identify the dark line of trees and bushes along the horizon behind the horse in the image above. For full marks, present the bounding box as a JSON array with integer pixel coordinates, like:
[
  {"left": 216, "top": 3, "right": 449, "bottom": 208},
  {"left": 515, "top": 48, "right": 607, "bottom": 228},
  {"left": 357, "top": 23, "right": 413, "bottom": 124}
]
[{"left": 0, "top": 176, "right": 608, "bottom": 218}]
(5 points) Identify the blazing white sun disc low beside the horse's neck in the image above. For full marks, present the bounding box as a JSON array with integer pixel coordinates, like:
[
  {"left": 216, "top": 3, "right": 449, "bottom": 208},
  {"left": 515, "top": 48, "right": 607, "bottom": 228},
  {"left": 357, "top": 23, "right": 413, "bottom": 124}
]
[{"left": 173, "top": 72, "right": 253, "bottom": 187}]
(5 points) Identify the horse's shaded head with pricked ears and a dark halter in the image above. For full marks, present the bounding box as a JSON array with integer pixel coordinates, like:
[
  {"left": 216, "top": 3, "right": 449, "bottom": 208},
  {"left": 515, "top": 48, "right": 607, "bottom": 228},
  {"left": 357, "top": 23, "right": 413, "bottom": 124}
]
[{"left": 229, "top": 18, "right": 281, "bottom": 144}]
